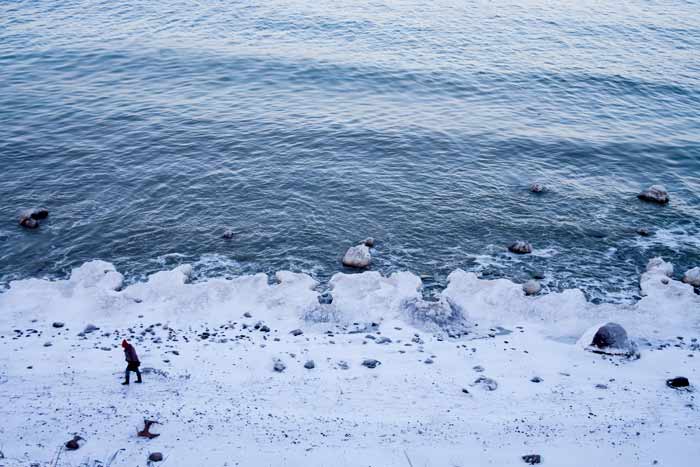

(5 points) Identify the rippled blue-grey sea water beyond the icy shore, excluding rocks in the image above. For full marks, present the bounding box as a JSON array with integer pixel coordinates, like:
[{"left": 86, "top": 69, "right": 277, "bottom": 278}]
[{"left": 0, "top": 0, "right": 700, "bottom": 300}]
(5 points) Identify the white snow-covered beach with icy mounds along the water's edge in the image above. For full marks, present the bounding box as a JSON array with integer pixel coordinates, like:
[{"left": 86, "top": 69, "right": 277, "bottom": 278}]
[{"left": 0, "top": 258, "right": 700, "bottom": 467}]
